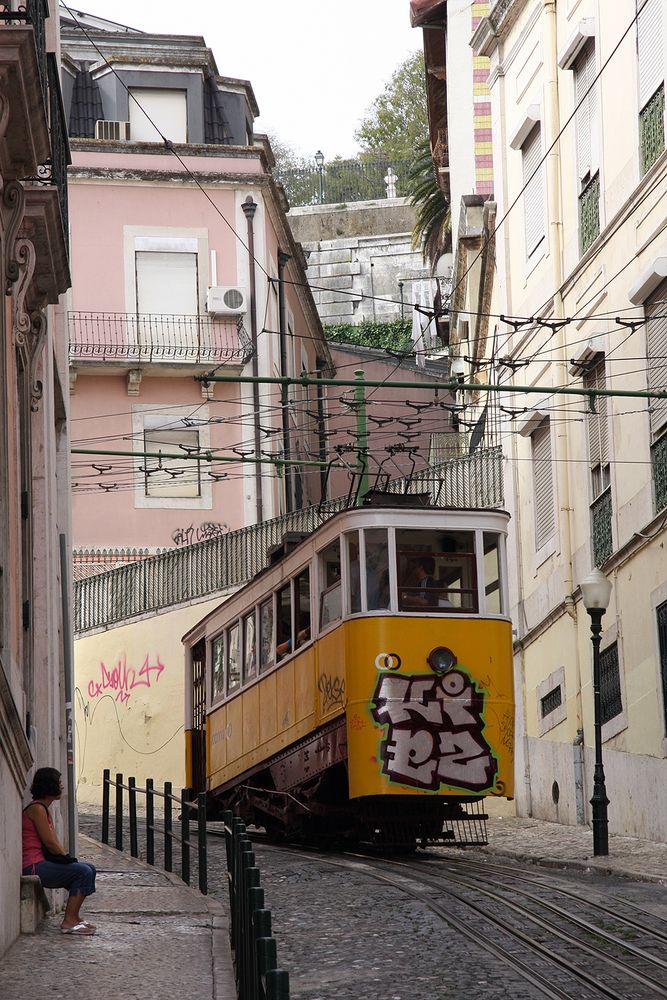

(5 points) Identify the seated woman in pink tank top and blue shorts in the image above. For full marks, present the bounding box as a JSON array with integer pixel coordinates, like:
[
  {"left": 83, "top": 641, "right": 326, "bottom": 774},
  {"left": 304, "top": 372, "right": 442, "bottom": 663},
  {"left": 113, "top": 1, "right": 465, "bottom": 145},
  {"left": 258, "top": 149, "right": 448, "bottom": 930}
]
[{"left": 21, "top": 767, "right": 96, "bottom": 935}]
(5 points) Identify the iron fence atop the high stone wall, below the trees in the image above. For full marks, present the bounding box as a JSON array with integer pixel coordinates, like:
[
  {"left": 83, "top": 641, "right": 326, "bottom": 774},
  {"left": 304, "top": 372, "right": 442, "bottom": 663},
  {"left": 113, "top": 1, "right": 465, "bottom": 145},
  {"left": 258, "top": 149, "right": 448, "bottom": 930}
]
[{"left": 276, "top": 160, "right": 411, "bottom": 207}]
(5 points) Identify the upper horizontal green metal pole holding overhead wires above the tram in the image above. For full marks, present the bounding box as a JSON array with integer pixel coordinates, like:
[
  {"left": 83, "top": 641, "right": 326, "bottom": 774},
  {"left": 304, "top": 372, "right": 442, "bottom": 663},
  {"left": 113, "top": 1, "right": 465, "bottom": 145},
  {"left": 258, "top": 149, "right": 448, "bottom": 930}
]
[{"left": 194, "top": 375, "right": 667, "bottom": 399}]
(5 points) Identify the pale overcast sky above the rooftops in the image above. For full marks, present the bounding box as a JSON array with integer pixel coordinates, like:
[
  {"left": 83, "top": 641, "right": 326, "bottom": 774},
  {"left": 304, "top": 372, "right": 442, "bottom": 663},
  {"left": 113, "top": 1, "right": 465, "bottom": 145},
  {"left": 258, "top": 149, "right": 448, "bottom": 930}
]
[{"left": 68, "top": 0, "right": 422, "bottom": 159}]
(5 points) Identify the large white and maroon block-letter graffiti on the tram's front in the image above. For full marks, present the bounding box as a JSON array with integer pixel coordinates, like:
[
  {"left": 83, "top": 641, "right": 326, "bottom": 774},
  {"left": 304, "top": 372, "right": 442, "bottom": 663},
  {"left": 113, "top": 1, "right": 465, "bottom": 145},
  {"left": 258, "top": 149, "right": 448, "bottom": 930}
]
[{"left": 371, "top": 664, "right": 498, "bottom": 792}]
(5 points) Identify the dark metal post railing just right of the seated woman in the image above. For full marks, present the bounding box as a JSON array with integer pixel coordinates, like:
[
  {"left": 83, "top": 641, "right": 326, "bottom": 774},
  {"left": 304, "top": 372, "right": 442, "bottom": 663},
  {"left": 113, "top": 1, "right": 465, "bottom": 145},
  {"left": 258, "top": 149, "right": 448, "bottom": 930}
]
[{"left": 102, "top": 768, "right": 208, "bottom": 895}]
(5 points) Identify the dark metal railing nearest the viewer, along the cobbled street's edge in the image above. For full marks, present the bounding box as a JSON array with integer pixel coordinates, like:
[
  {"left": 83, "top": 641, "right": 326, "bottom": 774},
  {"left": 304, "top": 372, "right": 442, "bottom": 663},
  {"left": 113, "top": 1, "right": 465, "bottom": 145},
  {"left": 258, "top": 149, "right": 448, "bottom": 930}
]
[{"left": 223, "top": 812, "right": 289, "bottom": 1000}]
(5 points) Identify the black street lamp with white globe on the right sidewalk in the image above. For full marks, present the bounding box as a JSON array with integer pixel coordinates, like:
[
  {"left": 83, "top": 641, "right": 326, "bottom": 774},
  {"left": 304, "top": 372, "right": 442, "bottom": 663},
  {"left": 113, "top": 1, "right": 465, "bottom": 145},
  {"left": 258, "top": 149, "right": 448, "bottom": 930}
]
[{"left": 580, "top": 568, "right": 611, "bottom": 857}]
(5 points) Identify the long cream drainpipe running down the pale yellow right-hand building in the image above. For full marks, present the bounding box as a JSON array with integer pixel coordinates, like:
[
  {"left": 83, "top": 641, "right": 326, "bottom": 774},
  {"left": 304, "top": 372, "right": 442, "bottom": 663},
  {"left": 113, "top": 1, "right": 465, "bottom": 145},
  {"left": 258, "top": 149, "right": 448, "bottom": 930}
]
[{"left": 543, "top": 0, "right": 585, "bottom": 823}]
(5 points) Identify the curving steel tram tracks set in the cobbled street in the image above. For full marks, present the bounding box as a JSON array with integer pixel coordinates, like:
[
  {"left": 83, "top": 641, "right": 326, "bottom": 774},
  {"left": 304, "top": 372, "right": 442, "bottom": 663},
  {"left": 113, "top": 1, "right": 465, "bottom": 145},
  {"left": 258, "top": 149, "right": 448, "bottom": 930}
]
[{"left": 232, "top": 834, "right": 667, "bottom": 1000}]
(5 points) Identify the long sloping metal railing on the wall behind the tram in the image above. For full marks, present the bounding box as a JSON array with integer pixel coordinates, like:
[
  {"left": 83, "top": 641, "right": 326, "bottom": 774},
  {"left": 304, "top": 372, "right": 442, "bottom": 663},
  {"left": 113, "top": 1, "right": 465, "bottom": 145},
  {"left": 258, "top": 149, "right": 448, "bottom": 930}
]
[{"left": 74, "top": 448, "right": 503, "bottom": 635}]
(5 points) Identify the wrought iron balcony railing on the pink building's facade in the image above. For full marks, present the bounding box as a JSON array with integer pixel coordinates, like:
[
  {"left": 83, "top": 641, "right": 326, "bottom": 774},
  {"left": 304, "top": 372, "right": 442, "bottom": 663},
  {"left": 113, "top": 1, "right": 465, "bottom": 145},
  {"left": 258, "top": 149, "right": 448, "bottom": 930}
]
[{"left": 69, "top": 312, "right": 252, "bottom": 364}]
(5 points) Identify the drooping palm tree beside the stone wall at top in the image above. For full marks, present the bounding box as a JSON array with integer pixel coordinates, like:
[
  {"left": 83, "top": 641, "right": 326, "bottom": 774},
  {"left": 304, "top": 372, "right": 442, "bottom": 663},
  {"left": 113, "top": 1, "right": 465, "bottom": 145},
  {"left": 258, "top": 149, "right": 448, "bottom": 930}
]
[{"left": 407, "top": 139, "right": 451, "bottom": 272}]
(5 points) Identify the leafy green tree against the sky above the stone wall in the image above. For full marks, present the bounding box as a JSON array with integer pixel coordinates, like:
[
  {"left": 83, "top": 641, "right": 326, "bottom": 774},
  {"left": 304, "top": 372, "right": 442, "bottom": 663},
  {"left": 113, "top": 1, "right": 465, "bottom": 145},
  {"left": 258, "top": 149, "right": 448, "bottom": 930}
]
[{"left": 354, "top": 52, "right": 428, "bottom": 160}]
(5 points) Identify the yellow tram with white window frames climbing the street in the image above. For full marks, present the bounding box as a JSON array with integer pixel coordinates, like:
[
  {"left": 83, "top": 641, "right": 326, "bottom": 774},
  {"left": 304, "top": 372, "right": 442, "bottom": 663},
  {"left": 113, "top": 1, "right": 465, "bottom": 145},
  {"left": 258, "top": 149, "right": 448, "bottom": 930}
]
[{"left": 183, "top": 497, "right": 514, "bottom": 846}]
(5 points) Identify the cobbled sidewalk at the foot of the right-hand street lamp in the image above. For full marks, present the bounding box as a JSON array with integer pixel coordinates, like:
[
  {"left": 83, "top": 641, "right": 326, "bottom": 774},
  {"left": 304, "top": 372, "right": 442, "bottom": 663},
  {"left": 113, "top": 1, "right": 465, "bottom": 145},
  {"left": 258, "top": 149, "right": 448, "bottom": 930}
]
[{"left": 484, "top": 817, "right": 667, "bottom": 885}]
